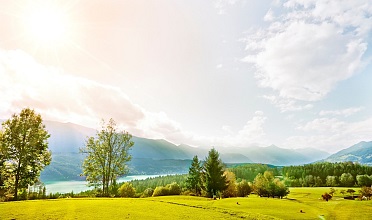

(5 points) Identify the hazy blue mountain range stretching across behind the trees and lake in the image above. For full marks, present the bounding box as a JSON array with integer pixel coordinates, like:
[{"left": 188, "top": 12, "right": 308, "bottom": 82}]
[{"left": 34, "top": 121, "right": 372, "bottom": 180}]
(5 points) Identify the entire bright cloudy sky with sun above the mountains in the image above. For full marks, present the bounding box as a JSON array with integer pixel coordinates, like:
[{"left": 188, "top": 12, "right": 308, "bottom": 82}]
[{"left": 0, "top": 0, "right": 372, "bottom": 153}]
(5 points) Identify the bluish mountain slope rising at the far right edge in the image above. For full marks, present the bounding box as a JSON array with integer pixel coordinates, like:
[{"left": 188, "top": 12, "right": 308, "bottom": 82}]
[{"left": 324, "top": 141, "right": 372, "bottom": 165}]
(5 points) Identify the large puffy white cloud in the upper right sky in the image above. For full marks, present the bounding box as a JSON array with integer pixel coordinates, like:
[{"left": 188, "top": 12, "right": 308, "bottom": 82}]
[{"left": 243, "top": 0, "right": 372, "bottom": 101}]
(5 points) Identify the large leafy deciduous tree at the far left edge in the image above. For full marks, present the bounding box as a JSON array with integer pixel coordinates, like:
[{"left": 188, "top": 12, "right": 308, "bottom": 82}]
[{"left": 0, "top": 108, "right": 51, "bottom": 200}]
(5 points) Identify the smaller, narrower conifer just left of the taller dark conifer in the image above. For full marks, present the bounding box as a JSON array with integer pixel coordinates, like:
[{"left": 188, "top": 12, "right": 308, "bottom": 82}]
[{"left": 186, "top": 156, "right": 202, "bottom": 195}]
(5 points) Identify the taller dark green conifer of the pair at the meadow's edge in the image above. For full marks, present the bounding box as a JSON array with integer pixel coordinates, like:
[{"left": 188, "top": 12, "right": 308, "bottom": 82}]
[{"left": 203, "top": 148, "right": 228, "bottom": 197}]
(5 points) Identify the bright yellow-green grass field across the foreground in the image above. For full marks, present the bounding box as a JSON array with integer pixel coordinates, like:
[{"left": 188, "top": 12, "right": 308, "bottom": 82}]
[{"left": 0, "top": 188, "right": 372, "bottom": 219}]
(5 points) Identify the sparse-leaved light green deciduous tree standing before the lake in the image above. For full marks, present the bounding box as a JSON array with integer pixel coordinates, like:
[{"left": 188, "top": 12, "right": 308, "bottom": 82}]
[{"left": 80, "top": 119, "right": 134, "bottom": 196}]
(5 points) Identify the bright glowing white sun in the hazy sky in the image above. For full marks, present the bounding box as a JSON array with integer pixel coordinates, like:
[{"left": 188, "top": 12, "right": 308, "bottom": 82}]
[{"left": 22, "top": 4, "right": 69, "bottom": 47}]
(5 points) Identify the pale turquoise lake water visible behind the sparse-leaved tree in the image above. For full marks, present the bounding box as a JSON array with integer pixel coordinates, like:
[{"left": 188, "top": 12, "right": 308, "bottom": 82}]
[{"left": 45, "top": 175, "right": 163, "bottom": 194}]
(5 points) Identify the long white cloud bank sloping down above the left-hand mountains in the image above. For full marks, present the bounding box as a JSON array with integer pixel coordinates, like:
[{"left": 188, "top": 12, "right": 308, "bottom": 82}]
[{"left": 0, "top": 50, "right": 180, "bottom": 138}]
